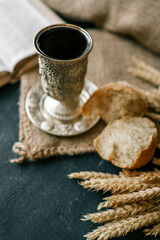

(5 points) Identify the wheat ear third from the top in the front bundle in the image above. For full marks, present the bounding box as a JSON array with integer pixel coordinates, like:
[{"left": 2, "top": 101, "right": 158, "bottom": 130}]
[{"left": 97, "top": 187, "right": 160, "bottom": 210}]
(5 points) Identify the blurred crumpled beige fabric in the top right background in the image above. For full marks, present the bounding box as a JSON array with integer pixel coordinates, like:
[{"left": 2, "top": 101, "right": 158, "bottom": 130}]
[{"left": 43, "top": 0, "right": 160, "bottom": 53}]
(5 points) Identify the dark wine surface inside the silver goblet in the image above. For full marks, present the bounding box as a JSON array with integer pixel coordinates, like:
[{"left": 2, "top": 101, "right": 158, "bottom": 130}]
[{"left": 37, "top": 27, "right": 88, "bottom": 60}]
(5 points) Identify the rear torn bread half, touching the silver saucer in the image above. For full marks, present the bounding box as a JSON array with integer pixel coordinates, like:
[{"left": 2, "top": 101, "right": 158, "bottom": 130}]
[{"left": 82, "top": 82, "right": 147, "bottom": 123}]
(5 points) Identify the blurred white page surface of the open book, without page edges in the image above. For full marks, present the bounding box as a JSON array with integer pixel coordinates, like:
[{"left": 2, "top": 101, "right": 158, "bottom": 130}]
[{"left": 0, "top": 0, "right": 62, "bottom": 72}]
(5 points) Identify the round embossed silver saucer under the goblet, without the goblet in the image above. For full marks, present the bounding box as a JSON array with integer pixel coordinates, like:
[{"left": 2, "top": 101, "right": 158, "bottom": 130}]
[{"left": 25, "top": 80, "right": 99, "bottom": 137}]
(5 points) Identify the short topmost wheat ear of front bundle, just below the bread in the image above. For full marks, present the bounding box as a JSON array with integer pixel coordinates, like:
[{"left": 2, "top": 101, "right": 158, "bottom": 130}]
[{"left": 68, "top": 171, "right": 118, "bottom": 180}]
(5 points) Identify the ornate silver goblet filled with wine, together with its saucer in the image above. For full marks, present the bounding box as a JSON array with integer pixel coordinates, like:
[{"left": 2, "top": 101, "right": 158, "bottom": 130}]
[{"left": 26, "top": 24, "right": 98, "bottom": 136}]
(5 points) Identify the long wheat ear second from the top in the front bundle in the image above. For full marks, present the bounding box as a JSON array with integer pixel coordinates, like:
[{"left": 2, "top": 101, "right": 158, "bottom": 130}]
[{"left": 80, "top": 178, "right": 160, "bottom": 193}]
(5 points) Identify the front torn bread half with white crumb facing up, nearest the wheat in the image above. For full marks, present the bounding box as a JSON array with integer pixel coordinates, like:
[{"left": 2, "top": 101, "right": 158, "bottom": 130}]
[{"left": 94, "top": 117, "right": 157, "bottom": 169}]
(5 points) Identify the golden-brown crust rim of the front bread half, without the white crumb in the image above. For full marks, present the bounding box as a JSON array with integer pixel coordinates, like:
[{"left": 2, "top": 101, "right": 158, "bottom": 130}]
[{"left": 93, "top": 117, "right": 157, "bottom": 169}]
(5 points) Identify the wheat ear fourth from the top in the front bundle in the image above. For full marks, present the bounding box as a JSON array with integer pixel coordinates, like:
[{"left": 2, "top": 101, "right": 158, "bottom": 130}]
[{"left": 81, "top": 199, "right": 160, "bottom": 223}]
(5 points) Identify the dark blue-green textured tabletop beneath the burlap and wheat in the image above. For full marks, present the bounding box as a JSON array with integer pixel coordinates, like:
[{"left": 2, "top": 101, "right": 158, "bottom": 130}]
[{"left": 0, "top": 83, "right": 160, "bottom": 240}]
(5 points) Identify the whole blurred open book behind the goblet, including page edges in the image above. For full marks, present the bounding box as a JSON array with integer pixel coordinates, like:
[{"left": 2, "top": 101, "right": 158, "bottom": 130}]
[{"left": 0, "top": 0, "right": 63, "bottom": 87}]
